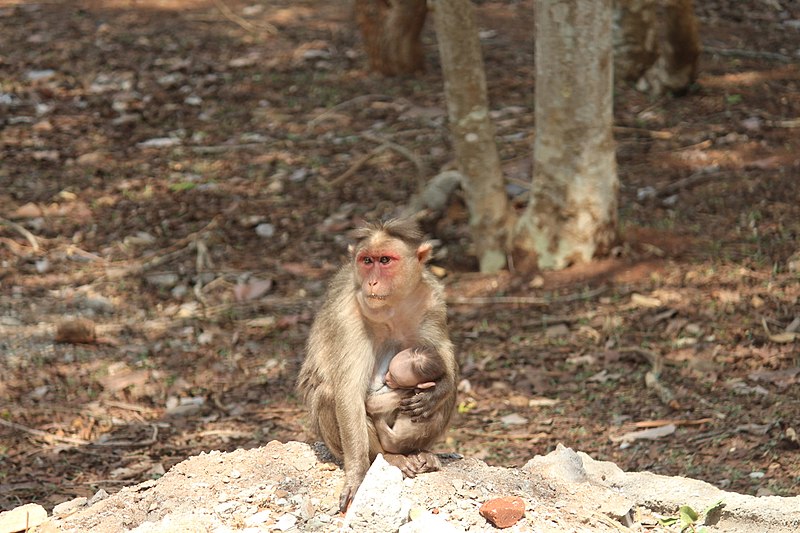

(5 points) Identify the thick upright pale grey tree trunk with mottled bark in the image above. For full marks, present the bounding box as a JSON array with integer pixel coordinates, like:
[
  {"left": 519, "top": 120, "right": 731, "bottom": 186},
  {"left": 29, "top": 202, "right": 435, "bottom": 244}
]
[{"left": 514, "top": 0, "right": 619, "bottom": 269}]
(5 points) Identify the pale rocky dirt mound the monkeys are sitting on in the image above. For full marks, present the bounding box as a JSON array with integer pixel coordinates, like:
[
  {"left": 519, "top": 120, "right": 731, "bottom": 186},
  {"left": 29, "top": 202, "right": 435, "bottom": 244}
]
[{"left": 6, "top": 441, "right": 800, "bottom": 533}]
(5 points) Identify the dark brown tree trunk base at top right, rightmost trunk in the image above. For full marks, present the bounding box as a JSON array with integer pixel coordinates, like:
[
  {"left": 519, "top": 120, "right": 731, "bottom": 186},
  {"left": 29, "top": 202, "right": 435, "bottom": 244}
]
[{"left": 614, "top": 0, "right": 700, "bottom": 95}]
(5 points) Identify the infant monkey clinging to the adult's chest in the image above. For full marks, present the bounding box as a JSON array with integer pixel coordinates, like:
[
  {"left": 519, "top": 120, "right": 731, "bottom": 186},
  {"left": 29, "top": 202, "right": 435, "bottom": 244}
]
[{"left": 367, "top": 348, "right": 449, "bottom": 453}]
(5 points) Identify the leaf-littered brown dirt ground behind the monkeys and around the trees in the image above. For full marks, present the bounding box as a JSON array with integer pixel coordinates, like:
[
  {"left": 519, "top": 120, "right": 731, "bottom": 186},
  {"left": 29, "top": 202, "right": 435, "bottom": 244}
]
[{"left": 0, "top": 0, "right": 800, "bottom": 509}]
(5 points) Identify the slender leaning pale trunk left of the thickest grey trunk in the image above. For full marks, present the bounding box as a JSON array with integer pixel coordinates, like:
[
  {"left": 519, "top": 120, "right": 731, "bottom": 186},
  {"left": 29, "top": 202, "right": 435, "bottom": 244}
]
[{"left": 432, "top": 0, "right": 510, "bottom": 272}]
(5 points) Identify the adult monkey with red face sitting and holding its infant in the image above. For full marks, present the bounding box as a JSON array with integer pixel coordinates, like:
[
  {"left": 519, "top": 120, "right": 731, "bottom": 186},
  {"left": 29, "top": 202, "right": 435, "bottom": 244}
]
[{"left": 297, "top": 219, "right": 458, "bottom": 511}]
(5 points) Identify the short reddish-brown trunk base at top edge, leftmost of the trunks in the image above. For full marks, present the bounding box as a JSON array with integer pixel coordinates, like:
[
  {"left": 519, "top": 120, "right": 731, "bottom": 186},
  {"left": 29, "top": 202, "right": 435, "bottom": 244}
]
[{"left": 354, "top": 0, "right": 428, "bottom": 76}]
